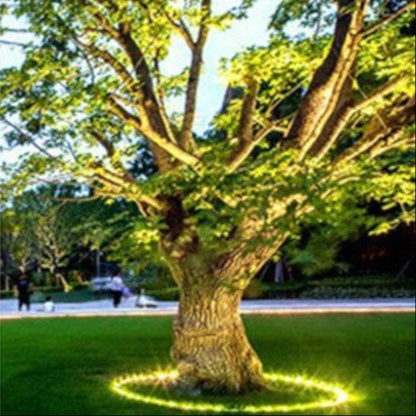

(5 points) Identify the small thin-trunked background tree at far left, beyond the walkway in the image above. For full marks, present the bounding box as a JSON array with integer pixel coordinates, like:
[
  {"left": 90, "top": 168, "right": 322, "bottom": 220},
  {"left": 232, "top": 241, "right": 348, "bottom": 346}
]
[{"left": 2, "top": 186, "right": 80, "bottom": 291}]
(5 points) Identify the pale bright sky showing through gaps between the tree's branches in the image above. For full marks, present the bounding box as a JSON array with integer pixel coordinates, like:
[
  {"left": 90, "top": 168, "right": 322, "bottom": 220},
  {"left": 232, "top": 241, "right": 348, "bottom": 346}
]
[{"left": 0, "top": 0, "right": 277, "bottom": 134}]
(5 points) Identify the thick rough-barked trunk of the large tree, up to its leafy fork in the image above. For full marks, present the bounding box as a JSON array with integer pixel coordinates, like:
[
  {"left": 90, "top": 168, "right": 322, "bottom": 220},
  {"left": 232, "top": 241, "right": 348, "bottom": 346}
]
[{"left": 161, "top": 208, "right": 284, "bottom": 393}]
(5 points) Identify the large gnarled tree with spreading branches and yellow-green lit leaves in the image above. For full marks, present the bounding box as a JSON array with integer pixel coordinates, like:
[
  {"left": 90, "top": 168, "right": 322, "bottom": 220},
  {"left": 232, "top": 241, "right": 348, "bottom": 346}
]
[{"left": 0, "top": 0, "right": 415, "bottom": 392}]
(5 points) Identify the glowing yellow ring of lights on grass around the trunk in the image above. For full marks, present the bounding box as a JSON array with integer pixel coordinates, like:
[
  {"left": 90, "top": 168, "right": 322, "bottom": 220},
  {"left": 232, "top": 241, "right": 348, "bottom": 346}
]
[{"left": 111, "top": 371, "right": 350, "bottom": 414}]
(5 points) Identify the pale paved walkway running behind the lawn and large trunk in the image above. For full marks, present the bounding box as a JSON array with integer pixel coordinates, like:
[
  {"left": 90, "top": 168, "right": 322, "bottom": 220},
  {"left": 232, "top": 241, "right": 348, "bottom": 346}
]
[{"left": 0, "top": 297, "right": 415, "bottom": 320}]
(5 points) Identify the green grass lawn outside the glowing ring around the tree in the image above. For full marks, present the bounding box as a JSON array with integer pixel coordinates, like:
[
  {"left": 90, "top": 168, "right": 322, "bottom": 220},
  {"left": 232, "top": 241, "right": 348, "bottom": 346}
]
[{"left": 1, "top": 314, "right": 415, "bottom": 415}]
